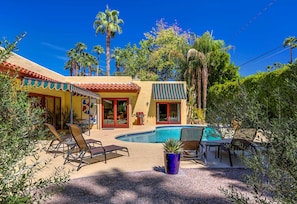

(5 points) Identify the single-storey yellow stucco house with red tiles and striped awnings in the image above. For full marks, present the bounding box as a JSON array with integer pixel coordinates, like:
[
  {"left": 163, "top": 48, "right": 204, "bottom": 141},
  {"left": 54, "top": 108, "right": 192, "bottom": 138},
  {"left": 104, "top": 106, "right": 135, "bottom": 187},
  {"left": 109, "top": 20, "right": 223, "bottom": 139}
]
[{"left": 0, "top": 54, "right": 187, "bottom": 129}]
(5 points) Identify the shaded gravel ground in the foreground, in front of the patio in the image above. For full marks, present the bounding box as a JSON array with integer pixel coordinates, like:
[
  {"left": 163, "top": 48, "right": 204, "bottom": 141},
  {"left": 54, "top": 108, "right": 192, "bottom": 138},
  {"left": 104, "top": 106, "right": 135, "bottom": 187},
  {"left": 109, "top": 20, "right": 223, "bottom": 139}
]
[{"left": 47, "top": 167, "right": 249, "bottom": 204}]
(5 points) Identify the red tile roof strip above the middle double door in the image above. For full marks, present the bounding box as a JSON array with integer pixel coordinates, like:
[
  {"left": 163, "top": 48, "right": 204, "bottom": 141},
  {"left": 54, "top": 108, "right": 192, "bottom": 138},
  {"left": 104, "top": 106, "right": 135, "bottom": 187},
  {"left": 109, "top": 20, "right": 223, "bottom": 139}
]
[{"left": 75, "top": 82, "right": 140, "bottom": 93}]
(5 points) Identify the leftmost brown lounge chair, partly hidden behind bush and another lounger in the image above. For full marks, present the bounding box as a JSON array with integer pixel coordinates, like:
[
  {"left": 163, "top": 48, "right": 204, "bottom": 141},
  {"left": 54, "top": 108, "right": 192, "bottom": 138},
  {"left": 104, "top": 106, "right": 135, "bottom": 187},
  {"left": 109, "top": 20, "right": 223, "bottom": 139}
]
[{"left": 44, "top": 123, "right": 72, "bottom": 157}]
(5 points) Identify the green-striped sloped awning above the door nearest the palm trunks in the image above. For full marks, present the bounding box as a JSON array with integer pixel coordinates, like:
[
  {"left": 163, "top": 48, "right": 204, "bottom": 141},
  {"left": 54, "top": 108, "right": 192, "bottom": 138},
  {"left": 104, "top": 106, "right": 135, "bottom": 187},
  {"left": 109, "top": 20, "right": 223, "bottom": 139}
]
[{"left": 153, "top": 83, "right": 187, "bottom": 100}]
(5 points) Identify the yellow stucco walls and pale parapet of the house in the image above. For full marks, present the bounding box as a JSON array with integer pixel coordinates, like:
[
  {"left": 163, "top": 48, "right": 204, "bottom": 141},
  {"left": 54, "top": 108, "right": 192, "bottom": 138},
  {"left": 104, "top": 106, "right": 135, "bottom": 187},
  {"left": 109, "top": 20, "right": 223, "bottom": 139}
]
[{"left": 8, "top": 54, "right": 187, "bottom": 128}]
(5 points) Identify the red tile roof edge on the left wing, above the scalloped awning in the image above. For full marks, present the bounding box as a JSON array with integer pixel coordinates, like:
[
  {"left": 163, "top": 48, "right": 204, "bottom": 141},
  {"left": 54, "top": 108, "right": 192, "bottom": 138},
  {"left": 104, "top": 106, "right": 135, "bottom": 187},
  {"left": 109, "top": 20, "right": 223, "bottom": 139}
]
[{"left": 0, "top": 62, "right": 56, "bottom": 81}]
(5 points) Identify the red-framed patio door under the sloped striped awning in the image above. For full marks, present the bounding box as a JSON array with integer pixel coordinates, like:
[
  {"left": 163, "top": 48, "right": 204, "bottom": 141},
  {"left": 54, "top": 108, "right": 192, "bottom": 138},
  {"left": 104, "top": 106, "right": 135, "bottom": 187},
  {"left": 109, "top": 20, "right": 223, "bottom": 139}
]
[{"left": 156, "top": 102, "right": 180, "bottom": 124}]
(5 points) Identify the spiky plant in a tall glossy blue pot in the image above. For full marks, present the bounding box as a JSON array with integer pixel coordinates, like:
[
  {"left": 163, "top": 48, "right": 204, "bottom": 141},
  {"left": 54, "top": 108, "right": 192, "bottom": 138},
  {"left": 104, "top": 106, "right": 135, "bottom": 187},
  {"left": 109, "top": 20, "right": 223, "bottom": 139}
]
[{"left": 163, "top": 139, "right": 183, "bottom": 174}]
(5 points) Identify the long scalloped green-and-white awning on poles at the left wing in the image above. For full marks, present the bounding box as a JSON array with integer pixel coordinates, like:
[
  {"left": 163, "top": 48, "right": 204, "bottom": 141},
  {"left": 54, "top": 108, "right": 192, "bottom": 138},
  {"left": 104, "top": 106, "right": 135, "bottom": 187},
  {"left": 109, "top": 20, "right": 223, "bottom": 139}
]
[{"left": 22, "top": 77, "right": 100, "bottom": 99}]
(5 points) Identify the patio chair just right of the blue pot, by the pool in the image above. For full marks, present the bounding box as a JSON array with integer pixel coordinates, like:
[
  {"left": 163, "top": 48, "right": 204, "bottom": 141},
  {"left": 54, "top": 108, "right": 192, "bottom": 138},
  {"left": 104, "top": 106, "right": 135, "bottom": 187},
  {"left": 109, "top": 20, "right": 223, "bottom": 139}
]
[{"left": 180, "top": 127, "right": 207, "bottom": 165}]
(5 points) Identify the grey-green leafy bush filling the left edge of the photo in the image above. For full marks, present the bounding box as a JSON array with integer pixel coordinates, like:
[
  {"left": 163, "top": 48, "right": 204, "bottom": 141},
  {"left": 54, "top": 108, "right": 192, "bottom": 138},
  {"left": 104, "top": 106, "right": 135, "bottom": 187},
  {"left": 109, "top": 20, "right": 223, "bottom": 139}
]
[{"left": 0, "top": 35, "right": 68, "bottom": 203}]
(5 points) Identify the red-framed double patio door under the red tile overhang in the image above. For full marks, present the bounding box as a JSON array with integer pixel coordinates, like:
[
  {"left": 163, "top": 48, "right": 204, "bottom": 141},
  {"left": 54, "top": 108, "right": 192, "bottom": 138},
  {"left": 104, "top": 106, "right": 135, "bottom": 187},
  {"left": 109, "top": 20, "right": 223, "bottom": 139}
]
[{"left": 102, "top": 98, "right": 129, "bottom": 128}]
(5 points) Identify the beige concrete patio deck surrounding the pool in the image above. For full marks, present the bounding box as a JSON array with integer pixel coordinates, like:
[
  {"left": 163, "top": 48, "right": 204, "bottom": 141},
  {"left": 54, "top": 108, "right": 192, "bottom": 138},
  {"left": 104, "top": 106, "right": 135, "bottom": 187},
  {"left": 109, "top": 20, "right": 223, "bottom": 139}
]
[{"left": 42, "top": 125, "right": 244, "bottom": 179}]
